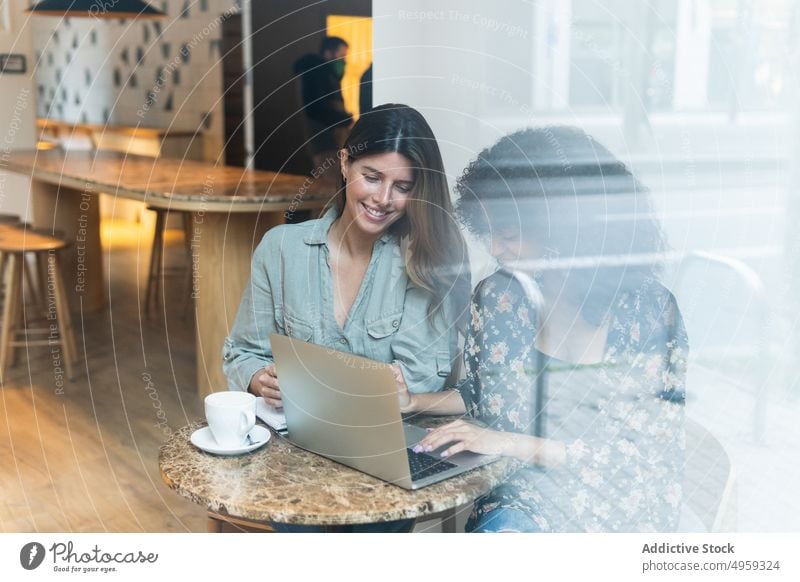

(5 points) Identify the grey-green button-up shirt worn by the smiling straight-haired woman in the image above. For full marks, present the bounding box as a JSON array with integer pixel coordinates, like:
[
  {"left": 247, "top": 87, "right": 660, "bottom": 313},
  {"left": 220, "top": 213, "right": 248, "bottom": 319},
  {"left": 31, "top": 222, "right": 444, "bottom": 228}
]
[{"left": 223, "top": 209, "right": 458, "bottom": 392}]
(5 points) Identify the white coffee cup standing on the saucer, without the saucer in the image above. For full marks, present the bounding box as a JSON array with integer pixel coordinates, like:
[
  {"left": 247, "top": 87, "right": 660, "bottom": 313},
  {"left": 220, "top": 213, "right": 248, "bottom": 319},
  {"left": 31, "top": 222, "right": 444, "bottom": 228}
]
[{"left": 205, "top": 391, "right": 256, "bottom": 449}]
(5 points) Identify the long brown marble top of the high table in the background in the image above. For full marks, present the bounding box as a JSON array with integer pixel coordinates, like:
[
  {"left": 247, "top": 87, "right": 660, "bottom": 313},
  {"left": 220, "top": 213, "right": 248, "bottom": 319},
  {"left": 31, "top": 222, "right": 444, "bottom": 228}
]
[{"left": 5, "top": 148, "right": 336, "bottom": 212}]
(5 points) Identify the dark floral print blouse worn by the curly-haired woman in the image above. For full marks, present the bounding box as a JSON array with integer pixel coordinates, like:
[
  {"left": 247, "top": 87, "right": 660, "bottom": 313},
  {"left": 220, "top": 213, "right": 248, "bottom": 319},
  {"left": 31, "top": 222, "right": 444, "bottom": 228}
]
[{"left": 458, "top": 271, "right": 688, "bottom": 532}]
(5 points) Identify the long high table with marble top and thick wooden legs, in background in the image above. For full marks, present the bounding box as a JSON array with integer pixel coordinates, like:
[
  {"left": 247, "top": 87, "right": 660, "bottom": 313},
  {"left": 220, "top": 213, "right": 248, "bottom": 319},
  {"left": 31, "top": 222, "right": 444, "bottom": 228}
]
[{"left": 6, "top": 149, "right": 333, "bottom": 397}]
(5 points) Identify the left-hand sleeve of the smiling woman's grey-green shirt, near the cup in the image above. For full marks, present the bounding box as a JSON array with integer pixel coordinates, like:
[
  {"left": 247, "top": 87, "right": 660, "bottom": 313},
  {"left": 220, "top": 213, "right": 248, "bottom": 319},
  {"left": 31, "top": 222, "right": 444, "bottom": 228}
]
[{"left": 222, "top": 234, "right": 283, "bottom": 391}]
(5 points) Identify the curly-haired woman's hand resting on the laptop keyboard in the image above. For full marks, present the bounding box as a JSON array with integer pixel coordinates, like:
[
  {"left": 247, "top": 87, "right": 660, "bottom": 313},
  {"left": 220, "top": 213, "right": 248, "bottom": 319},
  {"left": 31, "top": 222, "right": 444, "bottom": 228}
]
[{"left": 414, "top": 420, "right": 515, "bottom": 457}]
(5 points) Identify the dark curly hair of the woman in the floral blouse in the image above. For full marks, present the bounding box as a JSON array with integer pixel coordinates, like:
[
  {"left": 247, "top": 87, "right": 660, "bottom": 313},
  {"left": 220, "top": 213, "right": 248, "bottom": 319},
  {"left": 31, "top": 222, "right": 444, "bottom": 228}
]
[{"left": 456, "top": 126, "right": 666, "bottom": 325}]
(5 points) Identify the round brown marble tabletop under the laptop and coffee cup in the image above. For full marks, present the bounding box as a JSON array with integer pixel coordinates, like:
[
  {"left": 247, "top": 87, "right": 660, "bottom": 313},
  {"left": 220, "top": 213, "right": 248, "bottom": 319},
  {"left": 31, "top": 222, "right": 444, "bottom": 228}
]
[{"left": 159, "top": 421, "right": 515, "bottom": 526}]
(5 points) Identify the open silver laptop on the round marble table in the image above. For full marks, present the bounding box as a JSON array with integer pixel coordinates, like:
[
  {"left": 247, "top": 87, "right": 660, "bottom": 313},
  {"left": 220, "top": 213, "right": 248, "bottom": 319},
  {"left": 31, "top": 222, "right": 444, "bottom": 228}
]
[{"left": 270, "top": 334, "right": 497, "bottom": 489}]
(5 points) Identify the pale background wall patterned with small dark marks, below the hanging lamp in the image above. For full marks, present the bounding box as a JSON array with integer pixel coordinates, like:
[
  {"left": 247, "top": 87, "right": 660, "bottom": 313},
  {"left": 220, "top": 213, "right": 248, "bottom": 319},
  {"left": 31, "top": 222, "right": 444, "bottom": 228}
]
[{"left": 33, "top": 0, "right": 238, "bottom": 160}]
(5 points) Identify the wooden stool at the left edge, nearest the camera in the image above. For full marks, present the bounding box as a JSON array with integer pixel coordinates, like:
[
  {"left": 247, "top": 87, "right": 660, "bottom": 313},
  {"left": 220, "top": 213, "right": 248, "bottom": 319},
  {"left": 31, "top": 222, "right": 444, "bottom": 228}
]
[{"left": 0, "top": 225, "right": 77, "bottom": 379}]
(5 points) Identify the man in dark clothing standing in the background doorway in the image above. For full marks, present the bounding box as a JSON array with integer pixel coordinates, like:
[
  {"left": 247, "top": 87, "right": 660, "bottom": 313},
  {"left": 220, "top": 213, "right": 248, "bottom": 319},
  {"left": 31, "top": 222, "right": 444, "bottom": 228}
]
[{"left": 294, "top": 36, "right": 353, "bottom": 167}]
